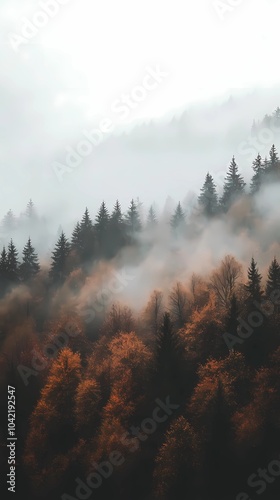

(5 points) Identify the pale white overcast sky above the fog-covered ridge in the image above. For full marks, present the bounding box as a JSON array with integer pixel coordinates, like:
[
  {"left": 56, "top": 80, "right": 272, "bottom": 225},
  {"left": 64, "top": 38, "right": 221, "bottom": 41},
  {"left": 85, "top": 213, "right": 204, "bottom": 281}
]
[{"left": 0, "top": 0, "right": 280, "bottom": 223}]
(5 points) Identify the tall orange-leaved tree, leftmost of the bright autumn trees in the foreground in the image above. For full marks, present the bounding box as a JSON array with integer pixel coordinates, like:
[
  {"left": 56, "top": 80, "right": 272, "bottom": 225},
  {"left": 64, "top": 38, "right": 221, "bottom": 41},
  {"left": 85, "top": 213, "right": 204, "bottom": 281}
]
[{"left": 24, "top": 348, "right": 81, "bottom": 494}]
